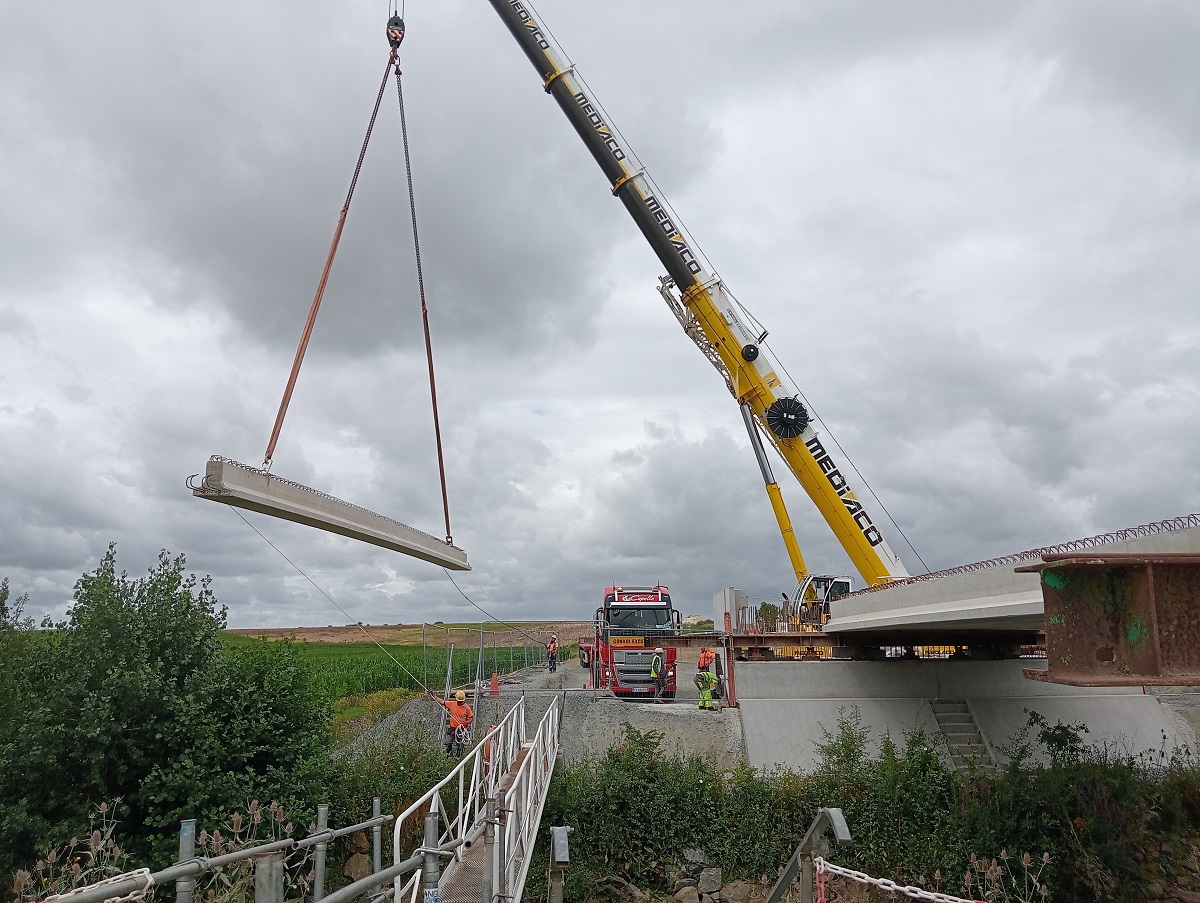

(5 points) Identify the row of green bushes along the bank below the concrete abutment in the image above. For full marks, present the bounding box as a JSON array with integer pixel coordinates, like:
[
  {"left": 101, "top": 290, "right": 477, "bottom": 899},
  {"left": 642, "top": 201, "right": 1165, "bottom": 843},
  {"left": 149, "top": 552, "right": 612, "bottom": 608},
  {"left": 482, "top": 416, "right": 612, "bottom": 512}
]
[{"left": 529, "top": 710, "right": 1200, "bottom": 902}]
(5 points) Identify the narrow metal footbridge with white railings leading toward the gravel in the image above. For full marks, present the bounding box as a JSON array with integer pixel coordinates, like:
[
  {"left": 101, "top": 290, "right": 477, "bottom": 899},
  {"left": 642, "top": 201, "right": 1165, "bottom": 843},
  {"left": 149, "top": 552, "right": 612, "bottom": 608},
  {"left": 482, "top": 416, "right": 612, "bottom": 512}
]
[{"left": 392, "top": 696, "right": 560, "bottom": 903}]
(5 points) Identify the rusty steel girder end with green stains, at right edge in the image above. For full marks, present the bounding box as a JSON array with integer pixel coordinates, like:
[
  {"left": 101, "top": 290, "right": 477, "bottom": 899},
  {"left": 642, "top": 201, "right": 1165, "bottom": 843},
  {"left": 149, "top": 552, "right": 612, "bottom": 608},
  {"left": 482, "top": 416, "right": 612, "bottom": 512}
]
[{"left": 1016, "top": 552, "right": 1200, "bottom": 687}]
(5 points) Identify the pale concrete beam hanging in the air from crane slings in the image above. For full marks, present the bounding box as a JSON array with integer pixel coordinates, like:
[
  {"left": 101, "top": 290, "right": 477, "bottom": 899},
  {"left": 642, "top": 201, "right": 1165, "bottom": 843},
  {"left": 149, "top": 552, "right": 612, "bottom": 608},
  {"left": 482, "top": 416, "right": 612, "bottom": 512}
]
[{"left": 188, "top": 456, "right": 470, "bottom": 570}]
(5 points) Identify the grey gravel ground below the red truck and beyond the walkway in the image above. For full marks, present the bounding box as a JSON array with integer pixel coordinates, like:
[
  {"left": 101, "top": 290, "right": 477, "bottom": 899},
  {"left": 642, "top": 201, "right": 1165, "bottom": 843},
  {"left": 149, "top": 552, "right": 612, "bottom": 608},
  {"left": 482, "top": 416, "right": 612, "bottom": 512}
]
[{"left": 354, "top": 650, "right": 745, "bottom": 767}]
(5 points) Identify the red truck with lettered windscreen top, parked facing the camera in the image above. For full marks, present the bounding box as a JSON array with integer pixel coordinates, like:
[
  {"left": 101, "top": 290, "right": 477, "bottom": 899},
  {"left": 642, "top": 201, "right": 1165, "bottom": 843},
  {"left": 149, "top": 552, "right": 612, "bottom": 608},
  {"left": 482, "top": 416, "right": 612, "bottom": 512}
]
[{"left": 580, "top": 586, "right": 682, "bottom": 699}]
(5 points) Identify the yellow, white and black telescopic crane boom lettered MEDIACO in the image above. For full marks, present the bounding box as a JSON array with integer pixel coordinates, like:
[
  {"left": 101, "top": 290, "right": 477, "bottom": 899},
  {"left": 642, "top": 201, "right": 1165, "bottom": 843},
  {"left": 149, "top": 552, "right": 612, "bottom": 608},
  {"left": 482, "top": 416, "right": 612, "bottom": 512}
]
[{"left": 490, "top": 0, "right": 907, "bottom": 585}]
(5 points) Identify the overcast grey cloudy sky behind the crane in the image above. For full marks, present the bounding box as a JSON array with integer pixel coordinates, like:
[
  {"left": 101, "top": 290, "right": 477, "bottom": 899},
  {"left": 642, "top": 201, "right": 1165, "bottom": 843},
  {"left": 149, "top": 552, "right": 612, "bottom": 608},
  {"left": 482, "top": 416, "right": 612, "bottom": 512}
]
[{"left": 0, "top": 0, "right": 1200, "bottom": 627}]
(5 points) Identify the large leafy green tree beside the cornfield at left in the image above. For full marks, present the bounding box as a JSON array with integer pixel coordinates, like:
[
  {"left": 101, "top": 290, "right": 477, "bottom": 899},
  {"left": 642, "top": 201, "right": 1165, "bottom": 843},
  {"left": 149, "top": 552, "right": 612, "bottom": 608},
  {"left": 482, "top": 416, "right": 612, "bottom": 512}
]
[{"left": 0, "top": 545, "right": 329, "bottom": 874}]
